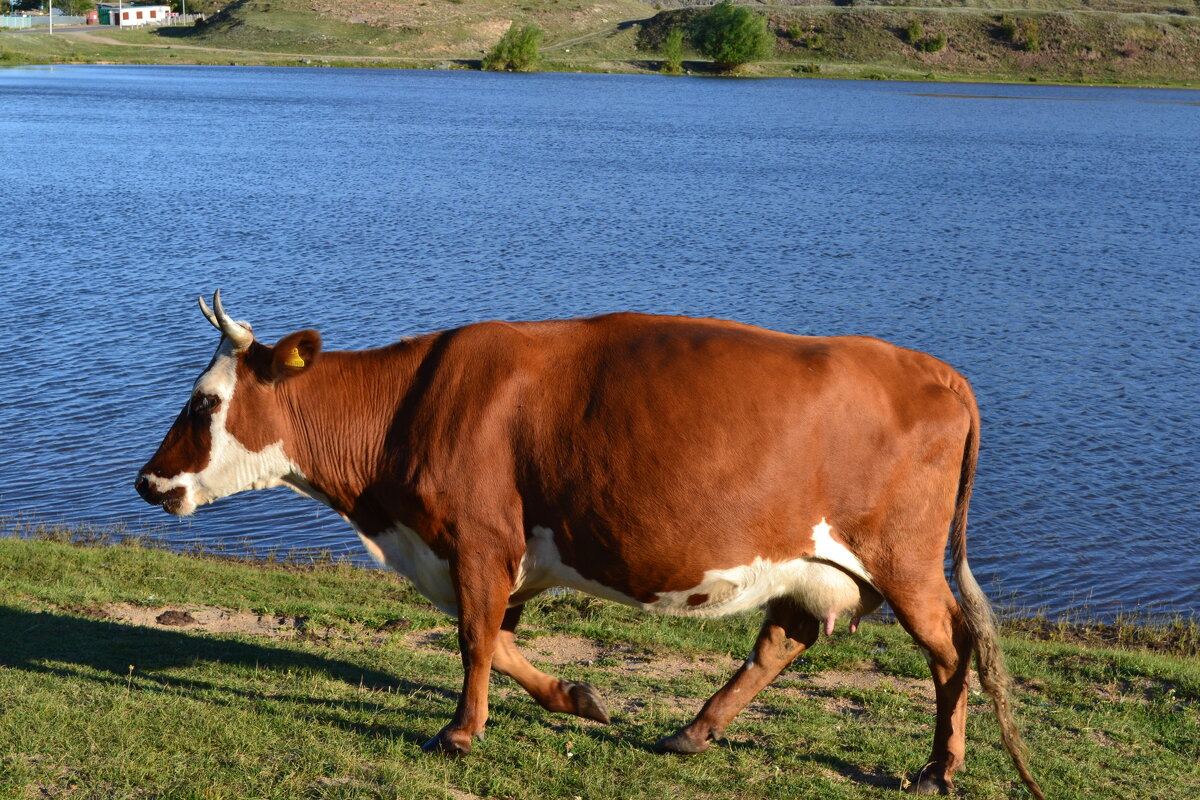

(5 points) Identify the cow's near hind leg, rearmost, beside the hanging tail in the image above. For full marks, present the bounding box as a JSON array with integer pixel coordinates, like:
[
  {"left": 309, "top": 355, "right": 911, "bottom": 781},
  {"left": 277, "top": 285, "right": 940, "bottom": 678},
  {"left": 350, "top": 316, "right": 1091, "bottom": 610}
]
[{"left": 884, "top": 575, "right": 973, "bottom": 794}]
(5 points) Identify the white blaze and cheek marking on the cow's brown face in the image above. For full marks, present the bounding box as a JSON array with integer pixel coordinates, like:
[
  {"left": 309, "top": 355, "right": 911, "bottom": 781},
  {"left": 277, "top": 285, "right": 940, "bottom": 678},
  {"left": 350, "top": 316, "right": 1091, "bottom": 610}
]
[{"left": 146, "top": 338, "right": 307, "bottom": 516}]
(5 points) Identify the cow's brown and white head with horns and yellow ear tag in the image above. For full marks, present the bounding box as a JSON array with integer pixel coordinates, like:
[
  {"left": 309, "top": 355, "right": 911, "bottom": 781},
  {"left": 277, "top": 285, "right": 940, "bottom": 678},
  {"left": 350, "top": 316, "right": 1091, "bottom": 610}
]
[{"left": 134, "top": 289, "right": 320, "bottom": 515}]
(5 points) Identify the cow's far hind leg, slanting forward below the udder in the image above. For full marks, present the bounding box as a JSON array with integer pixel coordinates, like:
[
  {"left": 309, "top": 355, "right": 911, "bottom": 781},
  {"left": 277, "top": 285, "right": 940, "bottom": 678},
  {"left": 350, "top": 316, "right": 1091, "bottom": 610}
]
[{"left": 654, "top": 600, "right": 821, "bottom": 753}]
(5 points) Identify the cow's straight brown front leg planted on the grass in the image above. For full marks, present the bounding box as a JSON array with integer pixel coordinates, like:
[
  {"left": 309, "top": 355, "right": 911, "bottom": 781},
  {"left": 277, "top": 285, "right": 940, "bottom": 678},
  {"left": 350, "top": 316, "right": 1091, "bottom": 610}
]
[{"left": 422, "top": 554, "right": 512, "bottom": 756}]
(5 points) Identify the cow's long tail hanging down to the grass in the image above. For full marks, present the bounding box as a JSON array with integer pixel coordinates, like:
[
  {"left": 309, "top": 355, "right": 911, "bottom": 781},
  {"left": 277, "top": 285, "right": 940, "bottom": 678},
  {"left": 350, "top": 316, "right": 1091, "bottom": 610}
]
[{"left": 950, "top": 380, "right": 1044, "bottom": 800}]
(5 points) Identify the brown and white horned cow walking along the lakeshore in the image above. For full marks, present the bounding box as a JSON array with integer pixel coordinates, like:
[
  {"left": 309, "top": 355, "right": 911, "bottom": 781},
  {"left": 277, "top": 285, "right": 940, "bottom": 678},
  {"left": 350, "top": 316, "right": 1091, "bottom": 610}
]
[{"left": 137, "top": 293, "right": 1042, "bottom": 798}]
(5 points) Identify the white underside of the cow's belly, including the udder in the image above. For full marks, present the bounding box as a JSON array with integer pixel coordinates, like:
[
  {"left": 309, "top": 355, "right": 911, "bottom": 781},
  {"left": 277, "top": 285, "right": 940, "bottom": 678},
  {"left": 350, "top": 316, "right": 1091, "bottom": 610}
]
[{"left": 510, "top": 519, "right": 882, "bottom": 620}]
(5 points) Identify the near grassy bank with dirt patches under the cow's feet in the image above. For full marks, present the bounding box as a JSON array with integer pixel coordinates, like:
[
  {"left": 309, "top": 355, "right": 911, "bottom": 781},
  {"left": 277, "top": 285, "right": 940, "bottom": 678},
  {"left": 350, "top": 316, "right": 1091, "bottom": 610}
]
[{"left": 0, "top": 539, "right": 1200, "bottom": 799}]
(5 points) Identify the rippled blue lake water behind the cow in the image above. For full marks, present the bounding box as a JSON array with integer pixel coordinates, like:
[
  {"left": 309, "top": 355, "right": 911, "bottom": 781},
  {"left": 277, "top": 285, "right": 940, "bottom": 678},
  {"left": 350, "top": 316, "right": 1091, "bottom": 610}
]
[{"left": 0, "top": 66, "right": 1200, "bottom": 616}]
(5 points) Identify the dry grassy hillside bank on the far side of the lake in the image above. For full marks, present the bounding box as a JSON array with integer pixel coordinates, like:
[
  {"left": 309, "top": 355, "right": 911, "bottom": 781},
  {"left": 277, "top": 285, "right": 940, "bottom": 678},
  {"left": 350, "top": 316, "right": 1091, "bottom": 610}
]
[{"left": 0, "top": 0, "right": 1200, "bottom": 86}]
